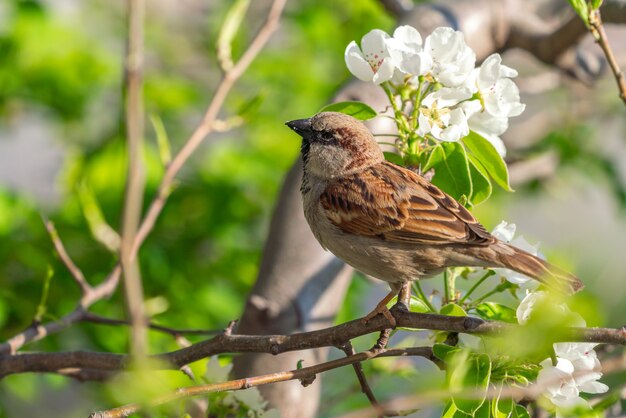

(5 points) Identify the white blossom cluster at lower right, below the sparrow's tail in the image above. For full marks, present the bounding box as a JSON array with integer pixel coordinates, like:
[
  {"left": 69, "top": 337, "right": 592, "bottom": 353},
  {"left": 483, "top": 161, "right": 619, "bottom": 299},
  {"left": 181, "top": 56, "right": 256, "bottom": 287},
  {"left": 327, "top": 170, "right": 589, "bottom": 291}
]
[{"left": 517, "top": 292, "right": 609, "bottom": 409}]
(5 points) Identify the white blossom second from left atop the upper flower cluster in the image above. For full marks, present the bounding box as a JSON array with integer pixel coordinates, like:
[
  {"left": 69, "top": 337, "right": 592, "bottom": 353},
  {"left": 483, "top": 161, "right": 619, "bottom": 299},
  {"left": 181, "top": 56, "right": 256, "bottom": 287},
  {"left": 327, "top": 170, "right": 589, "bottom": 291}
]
[{"left": 385, "top": 25, "right": 433, "bottom": 76}]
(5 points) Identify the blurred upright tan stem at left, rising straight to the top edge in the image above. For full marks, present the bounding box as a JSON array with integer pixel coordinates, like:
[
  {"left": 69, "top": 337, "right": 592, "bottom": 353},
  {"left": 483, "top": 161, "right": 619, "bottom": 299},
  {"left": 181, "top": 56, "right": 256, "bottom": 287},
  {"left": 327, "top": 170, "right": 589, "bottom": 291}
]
[{"left": 120, "top": 0, "right": 146, "bottom": 359}]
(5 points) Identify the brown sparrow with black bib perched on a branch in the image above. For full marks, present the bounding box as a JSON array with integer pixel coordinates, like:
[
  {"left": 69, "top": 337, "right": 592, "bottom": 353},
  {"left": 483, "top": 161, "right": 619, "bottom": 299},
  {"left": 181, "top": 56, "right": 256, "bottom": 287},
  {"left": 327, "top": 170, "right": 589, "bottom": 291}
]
[{"left": 286, "top": 112, "right": 583, "bottom": 322}]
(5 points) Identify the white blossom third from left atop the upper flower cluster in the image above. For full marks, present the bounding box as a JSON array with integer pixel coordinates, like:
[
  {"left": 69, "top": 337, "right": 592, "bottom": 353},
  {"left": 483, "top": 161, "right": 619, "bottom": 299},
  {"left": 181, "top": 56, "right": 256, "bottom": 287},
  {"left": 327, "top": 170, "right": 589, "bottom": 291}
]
[{"left": 424, "top": 27, "right": 476, "bottom": 87}]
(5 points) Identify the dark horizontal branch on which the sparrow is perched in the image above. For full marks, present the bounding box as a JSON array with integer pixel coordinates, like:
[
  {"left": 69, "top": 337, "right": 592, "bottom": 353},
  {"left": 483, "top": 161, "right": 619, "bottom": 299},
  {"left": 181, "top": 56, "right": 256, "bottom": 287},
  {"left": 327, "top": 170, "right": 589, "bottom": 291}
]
[{"left": 0, "top": 309, "right": 626, "bottom": 378}]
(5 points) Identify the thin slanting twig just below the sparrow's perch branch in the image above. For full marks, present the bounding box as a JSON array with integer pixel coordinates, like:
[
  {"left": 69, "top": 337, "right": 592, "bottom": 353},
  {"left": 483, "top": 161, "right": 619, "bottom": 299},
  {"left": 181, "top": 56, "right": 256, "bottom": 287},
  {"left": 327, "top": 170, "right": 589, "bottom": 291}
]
[{"left": 90, "top": 347, "right": 433, "bottom": 418}]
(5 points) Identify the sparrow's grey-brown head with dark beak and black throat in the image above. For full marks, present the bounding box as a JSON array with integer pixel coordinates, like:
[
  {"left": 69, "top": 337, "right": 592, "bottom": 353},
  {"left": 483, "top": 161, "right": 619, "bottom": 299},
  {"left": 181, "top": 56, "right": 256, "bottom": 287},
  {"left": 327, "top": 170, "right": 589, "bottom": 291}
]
[{"left": 286, "top": 112, "right": 384, "bottom": 178}]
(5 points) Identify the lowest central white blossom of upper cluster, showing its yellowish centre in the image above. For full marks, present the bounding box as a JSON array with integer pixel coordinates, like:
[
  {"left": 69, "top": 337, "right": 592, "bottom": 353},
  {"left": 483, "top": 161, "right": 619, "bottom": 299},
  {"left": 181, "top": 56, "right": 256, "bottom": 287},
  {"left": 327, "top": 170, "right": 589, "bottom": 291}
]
[{"left": 417, "top": 87, "right": 471, "bottom": 142}]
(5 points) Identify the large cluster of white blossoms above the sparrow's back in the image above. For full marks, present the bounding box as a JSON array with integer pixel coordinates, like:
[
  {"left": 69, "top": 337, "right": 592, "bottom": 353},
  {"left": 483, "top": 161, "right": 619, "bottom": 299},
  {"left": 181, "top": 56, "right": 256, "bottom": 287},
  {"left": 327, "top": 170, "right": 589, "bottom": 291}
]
[{"left": 345, "top": 26, "right": 524, "bottom": 155}]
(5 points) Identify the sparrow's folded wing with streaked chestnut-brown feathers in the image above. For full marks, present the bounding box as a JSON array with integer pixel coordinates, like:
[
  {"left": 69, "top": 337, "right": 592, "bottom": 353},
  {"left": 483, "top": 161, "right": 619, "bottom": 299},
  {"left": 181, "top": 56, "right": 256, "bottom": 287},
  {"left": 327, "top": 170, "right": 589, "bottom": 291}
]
[{"left": 320, "top": 162, "right": 495, "bottom": 246}]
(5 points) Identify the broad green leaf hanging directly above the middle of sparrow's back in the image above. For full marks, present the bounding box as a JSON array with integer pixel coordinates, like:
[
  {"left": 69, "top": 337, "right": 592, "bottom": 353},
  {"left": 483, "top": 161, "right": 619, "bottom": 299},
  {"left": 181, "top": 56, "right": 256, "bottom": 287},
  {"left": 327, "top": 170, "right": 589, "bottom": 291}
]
[{"left": 423, "top": 142, "right": 472, "bottom": 200}]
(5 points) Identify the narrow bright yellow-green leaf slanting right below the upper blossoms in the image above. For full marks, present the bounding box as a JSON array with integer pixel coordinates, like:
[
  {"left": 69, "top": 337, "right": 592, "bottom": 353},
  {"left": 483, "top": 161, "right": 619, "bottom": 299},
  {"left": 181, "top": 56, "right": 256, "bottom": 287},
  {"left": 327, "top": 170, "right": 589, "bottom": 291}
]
[{"left": 463, "top": 131, "right": 513, "bottom": 192}]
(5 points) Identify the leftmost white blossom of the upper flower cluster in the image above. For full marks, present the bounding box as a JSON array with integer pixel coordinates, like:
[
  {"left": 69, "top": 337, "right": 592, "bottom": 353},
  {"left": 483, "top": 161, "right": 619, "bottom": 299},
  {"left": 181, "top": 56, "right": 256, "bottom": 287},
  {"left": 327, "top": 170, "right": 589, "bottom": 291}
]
[{"left": 345, "top": 29, "right": 396, "bottom": 84}]
